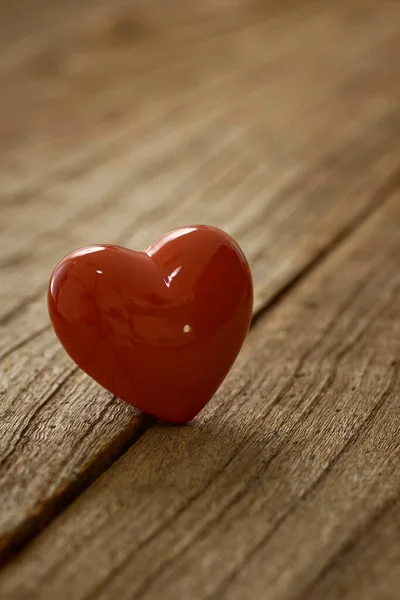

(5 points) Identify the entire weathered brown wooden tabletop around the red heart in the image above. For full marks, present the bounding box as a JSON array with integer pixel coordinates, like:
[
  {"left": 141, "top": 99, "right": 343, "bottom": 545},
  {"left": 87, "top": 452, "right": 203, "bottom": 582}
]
[{"left": 0, "top": 0, "right": 400, "bottom": 600}]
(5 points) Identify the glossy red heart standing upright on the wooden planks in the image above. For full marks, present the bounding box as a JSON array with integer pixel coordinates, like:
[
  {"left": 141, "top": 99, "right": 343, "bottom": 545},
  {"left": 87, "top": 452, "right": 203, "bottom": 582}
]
[{"left": 48, "top": 225, "right": 253, "bottom": 423}]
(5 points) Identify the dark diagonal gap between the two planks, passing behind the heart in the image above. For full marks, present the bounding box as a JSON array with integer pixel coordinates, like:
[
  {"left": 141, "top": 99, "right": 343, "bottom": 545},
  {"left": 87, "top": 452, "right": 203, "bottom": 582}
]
[{"left": 0, "top": 167, "right": 400, "bottom": 564}]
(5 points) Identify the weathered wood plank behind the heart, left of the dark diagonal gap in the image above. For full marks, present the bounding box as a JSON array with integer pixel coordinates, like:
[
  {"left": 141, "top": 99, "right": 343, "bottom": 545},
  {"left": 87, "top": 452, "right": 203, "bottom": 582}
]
[{"left": 0, "top": 1, "right": 400, "bottom": 572}]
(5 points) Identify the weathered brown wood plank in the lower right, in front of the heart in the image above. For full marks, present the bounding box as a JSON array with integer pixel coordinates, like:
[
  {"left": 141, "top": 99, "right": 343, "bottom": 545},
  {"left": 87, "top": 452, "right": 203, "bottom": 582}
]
[{"left": 0, "top": 191, "right": 400, "bottom": 600}]
